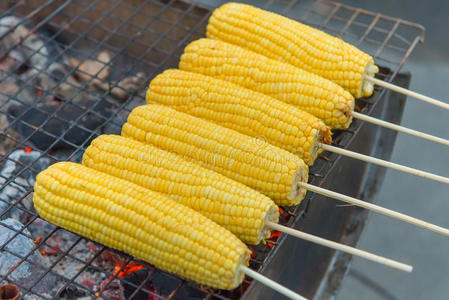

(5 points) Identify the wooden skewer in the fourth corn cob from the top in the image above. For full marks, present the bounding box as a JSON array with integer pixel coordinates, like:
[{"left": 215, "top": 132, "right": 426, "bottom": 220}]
[{"left": 298, "top": 182, "right": 449, "bottom": 236}]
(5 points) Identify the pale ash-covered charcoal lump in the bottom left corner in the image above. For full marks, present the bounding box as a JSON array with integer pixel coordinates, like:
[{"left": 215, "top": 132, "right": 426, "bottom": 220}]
[{"left": 0, "top": 219, "right": 56, "bottom": 293}]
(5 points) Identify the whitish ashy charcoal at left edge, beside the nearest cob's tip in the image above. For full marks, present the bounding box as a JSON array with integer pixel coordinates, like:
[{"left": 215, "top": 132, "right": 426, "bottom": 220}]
[{"left": 0, "top": 150, "right": 50, "bottom": 222}]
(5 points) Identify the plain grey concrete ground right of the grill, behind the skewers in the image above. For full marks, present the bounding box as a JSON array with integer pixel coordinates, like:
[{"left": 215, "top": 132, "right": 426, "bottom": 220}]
[{"left": 337, "top": 0, "right": 449, "bottom": 300}]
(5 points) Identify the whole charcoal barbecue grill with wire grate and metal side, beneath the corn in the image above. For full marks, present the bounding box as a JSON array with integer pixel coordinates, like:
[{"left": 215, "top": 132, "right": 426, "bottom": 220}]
[{"left": 0, "top": 0, "right": 424, "bottom": 299}]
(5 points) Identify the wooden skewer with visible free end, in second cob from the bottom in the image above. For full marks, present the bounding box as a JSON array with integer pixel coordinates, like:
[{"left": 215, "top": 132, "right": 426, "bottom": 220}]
[{"left": 266, "top": 221, "right": 413, "bottom": 273}]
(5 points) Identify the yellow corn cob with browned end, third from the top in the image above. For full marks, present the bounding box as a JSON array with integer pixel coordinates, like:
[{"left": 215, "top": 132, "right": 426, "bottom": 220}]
[{"left": 146, "top": 70, "right": 332, "bottom": 165}]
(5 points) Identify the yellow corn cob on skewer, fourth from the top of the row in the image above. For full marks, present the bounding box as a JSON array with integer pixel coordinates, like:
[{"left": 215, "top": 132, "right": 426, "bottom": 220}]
[{"left": 122, "top": 104, "right": 308, "bottom": 205}]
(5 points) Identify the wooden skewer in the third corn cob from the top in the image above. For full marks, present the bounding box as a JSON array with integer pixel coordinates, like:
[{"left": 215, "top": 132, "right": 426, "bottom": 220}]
[{"left": 319, "top": 143, "right": 449, "bottom": 183}]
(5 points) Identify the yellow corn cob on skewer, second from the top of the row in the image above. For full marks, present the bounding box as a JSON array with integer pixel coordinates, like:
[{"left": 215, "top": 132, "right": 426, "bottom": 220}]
[{"left": 179, "top": 39, "right": 354, "bottom": 129}]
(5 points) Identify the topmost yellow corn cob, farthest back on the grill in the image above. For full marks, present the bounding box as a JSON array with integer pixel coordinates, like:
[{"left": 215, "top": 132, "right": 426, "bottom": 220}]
[{"left": 207, "top": 3, "right": 379, "bottom": 97}]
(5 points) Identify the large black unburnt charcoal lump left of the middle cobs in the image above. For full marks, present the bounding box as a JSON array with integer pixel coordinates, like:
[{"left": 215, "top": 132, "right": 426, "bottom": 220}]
[{"left": 8, "top": 101, "right": 110, "bottom": 150}]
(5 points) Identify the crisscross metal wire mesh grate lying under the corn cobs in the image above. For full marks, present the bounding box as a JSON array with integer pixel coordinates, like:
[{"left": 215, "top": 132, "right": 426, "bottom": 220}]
[{"left": 0, "top": 0, "right": 424, "bottom": 299}]
